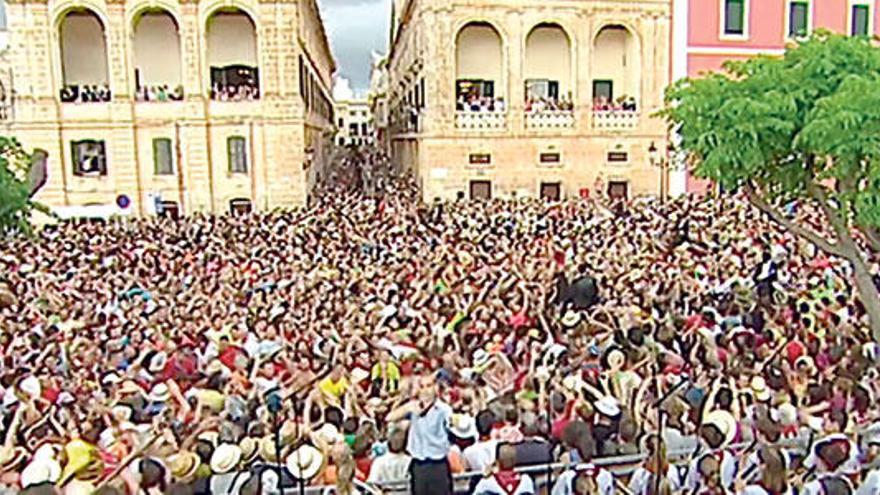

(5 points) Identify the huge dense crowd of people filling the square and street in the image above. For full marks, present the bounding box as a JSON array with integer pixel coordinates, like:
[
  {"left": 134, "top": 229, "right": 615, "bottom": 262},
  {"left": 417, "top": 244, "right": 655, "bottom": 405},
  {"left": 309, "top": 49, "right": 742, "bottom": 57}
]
[{"left": 0, "top": 155, "right": 880, "bottom": 495}]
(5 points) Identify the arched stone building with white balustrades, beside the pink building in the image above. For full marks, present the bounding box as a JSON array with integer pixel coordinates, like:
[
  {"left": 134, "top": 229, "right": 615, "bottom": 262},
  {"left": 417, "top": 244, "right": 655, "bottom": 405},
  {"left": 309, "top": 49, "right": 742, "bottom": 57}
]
[{"left": 388, "top": 0, "right": 671, "bottom": 199}]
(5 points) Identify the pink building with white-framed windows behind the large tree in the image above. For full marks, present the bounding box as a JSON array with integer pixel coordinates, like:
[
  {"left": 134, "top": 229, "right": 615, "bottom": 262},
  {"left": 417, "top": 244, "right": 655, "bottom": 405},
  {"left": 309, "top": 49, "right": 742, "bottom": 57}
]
[{"left": 670, "top": 0, "right": 880, "bottom": 192}]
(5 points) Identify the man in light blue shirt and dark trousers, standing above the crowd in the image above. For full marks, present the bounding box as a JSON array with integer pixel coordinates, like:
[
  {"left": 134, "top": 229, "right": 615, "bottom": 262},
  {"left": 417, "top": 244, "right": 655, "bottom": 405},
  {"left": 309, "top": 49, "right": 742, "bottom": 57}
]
[{"left": 388, "top": 376, "right": 452, "bottom": 495}]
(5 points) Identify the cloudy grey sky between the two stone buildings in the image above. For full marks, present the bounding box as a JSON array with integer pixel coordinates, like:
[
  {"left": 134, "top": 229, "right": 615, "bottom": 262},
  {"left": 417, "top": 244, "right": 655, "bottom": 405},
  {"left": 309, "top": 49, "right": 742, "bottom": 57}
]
[{"left": 318, "top": 0, "right": 391, "bottom": 92}]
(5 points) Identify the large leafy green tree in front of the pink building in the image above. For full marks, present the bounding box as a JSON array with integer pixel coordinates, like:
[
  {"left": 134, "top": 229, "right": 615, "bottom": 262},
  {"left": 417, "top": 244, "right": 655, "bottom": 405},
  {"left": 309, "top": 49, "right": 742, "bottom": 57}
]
[{"left": 660, "top": 31, "right": 880, "bottom": 340}]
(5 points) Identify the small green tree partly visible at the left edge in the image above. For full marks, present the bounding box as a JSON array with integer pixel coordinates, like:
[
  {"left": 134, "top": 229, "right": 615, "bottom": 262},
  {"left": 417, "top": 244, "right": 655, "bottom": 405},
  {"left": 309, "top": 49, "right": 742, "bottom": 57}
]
[{"left": 0, "top": 136, "right": 46, "bottom": 235}]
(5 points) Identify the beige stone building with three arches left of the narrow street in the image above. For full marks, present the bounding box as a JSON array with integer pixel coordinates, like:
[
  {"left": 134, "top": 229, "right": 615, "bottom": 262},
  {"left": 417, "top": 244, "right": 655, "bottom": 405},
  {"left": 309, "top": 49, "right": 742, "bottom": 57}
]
[{"left": 0, "top": 0, "right": 335, "bottom": 215}]
